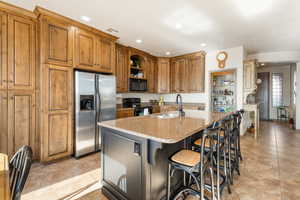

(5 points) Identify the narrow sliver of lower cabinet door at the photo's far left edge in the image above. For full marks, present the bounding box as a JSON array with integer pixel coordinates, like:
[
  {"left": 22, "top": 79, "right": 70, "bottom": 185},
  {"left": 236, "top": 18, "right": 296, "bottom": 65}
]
[{"left": 0, "top": 91, "right": 8, "bottom": 154}]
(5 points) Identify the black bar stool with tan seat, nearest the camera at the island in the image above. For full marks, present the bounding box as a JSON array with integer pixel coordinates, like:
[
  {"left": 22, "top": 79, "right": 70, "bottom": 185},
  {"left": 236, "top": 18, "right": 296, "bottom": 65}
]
[{"left": 167, "top": 130, "right": 215, "bottom": 200}]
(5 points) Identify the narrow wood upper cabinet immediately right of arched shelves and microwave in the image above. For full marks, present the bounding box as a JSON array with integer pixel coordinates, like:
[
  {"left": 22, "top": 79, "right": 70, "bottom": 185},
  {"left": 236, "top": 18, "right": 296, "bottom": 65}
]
[{"left": 146, "top": 56, "right": 157, "bottom": 93}]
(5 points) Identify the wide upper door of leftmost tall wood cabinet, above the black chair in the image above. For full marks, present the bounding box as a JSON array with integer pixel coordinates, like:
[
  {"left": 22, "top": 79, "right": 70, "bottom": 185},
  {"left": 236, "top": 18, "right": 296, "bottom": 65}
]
[{"left": 8, "top": 15, "right": 36, "bottom": 89}]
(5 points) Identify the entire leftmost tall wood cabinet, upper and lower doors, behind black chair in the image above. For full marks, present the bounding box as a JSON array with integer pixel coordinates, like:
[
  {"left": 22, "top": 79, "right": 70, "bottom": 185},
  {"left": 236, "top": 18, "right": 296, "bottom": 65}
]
[{"left": 0, "top": 3, "right": 39, "bottom": 158}]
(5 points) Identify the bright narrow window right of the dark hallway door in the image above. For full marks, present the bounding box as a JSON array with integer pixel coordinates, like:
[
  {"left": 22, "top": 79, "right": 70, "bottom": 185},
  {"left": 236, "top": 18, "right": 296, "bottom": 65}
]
[{"left": 272, "top": 73, "right": 283, "bottom": 107}]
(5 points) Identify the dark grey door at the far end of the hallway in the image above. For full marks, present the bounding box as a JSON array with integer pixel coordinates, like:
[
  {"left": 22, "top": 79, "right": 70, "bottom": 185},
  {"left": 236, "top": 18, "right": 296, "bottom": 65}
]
[{"left": 256, "top": 72, "right": 270, "bottom": 120}]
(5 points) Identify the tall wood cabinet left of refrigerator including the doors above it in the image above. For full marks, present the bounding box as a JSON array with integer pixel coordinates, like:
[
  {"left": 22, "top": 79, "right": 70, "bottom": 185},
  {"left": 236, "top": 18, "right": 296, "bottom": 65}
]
[{"left": 35, "top": 7, "right": 117, "bottom": 162}]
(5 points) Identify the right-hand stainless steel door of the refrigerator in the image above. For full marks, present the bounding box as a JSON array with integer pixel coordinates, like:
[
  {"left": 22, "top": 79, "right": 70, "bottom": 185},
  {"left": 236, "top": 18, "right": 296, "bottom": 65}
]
[{"left": 96, "top": 74, "right": 116, "bottom": 149}]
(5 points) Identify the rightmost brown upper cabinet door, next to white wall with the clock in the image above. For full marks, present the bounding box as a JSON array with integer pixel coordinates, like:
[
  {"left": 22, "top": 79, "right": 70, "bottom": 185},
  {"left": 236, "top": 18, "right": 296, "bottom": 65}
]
[{"left": 188, "top": 56, "right": 205, "bottom": 92}]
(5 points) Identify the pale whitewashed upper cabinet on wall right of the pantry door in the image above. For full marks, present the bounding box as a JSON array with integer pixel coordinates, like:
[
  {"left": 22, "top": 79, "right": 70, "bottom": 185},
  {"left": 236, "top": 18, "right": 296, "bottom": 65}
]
[{"left": 244, "top": 60, "right": 257, "bottom": 92}]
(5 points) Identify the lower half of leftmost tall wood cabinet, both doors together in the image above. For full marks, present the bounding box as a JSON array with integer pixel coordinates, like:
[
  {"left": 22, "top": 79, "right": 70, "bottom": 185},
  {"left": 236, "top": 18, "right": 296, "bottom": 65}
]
[{"left": 0, "top": 91, "right": 39, "bottom": 159}]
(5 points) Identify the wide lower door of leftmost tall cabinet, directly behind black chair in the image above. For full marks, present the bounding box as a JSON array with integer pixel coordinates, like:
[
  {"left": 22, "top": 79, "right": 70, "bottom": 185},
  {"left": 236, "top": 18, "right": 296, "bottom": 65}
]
[{"left": 8, "top": 91, "right": 37, "bottom": 157}]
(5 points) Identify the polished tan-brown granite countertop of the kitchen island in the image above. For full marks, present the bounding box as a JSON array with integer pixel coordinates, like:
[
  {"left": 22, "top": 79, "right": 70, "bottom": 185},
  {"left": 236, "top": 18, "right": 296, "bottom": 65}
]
[{"left": 99, "top": 110, "right": 230, "bottom": 143}]
